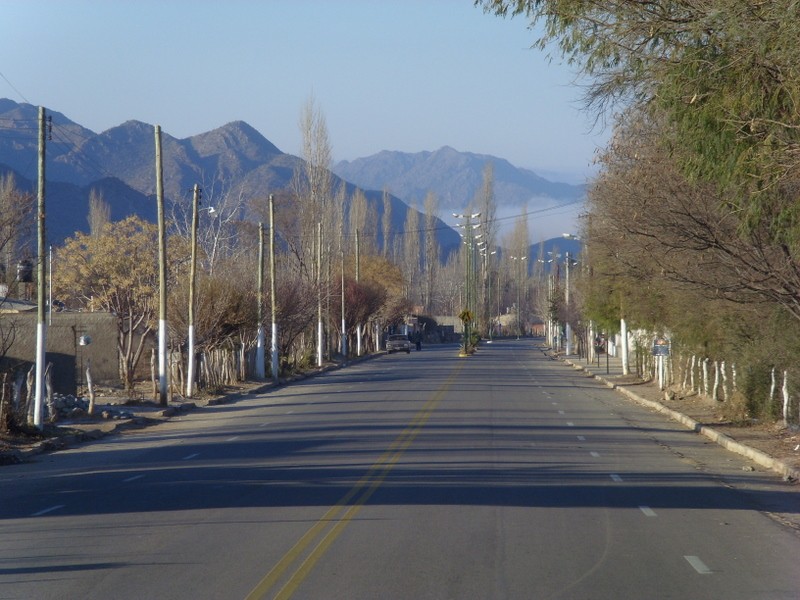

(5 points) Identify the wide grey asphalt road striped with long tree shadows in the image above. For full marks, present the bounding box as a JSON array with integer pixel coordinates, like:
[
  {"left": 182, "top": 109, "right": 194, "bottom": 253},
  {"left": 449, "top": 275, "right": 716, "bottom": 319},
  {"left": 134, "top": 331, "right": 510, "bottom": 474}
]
[{"left": 0, "top": 340, "right": 800, "bottom": 600}]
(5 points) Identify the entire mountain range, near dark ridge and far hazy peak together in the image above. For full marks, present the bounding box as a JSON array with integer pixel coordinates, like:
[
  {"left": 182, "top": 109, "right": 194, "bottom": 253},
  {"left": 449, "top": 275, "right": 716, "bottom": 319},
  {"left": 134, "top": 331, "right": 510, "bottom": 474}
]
[{"left": 0, "top": 99, "right": 585, "bottom": 258}]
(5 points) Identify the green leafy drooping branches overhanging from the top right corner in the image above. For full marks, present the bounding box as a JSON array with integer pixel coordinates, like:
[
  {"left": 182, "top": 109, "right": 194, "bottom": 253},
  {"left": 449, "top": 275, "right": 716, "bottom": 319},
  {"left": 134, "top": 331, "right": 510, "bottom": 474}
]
[{"left": 476, "top": 0, "right": 800, "bottom": 237}]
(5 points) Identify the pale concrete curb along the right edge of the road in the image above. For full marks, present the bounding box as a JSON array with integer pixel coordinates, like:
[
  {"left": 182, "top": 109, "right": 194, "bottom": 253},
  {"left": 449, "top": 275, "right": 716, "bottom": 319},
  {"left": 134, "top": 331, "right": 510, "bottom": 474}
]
[{"left": 564, "top": 359, "right": 800, "bottom": 481}]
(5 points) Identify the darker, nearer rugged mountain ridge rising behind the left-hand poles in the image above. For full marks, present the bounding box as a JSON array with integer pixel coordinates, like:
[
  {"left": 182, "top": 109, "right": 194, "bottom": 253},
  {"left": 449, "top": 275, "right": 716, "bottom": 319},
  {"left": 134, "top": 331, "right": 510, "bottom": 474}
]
[{"left": 0, "top": 99, "right": 460, "bottom": 248}]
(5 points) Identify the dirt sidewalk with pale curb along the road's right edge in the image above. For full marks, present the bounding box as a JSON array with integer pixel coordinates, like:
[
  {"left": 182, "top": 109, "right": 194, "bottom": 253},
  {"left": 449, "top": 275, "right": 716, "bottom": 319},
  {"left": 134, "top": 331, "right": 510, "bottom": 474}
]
[{"left": 542, "top": 348, "right": 800, "bottom": 482}]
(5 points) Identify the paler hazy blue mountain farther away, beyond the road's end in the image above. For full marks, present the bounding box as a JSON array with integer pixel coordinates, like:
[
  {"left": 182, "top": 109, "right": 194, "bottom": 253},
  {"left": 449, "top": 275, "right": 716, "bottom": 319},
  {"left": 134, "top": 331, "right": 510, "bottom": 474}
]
[{"left": 333, "top": 146, "right": 586, "bottom": 210}]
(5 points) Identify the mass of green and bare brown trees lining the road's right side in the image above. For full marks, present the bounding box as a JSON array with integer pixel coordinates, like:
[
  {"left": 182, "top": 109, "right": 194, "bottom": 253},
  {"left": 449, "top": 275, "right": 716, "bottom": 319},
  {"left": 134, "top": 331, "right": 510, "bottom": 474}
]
[{"left": 476, "top": 0, "right": 800, "bottom": 424}]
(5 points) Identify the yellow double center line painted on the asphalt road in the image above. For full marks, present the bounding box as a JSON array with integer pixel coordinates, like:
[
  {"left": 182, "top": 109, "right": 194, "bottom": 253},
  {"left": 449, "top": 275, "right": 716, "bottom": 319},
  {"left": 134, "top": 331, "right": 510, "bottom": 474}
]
[{"left": 247, "top": 362, "right": 464, "bottom": 600}]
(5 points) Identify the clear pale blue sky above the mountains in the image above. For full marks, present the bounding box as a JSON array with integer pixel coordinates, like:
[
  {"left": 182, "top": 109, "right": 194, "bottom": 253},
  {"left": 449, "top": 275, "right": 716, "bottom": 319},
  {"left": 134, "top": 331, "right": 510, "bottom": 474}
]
[{"left": 0, "top": 0, "right": 607, "bottom": 182}]
